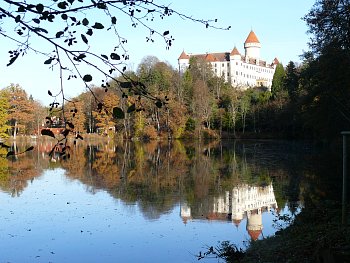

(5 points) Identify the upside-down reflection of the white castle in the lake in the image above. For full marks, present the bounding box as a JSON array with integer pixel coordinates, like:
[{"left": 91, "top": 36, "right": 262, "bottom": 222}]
[{"left": 180, "top": 183, "right": 278, "bottom": 240}]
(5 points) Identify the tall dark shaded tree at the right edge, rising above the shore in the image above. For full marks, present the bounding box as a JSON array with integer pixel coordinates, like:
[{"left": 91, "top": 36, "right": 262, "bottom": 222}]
[{"left": 302, "top": 0, "right": 350, "bottom": 140}]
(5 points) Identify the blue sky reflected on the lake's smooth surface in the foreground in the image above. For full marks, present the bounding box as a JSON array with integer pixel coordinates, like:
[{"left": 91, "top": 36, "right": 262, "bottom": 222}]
[{"left": 0, "top": 142, "right": 304, "bottom": 262}]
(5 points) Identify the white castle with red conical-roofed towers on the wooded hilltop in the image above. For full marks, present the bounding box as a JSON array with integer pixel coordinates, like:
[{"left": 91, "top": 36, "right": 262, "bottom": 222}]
[{"left": 178, "top": 30, "right": 279, "bottom": 90}]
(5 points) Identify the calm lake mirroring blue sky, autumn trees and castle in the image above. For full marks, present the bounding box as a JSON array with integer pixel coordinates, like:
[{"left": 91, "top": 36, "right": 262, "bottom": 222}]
[{"left": 0, "top": 140, "right": 314, "bottom": 262}]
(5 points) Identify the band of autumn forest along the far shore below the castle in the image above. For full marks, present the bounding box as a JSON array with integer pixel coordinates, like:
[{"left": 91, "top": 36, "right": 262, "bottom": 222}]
[{"left": 0, "top": 47, "right": 350, "bottom": 144}]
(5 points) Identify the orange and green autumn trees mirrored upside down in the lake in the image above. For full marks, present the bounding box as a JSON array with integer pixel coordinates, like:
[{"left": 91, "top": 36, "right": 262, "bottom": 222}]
[{"left": 0, "top": 139, "right": 317, "bottom": 227}]
